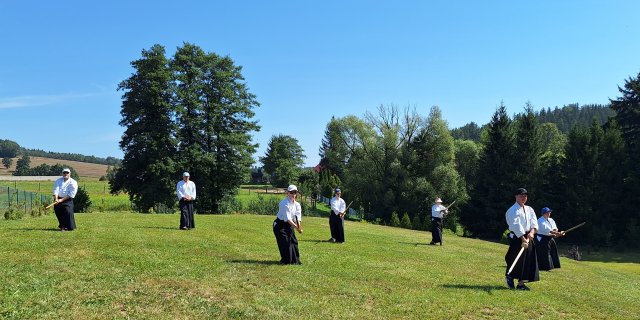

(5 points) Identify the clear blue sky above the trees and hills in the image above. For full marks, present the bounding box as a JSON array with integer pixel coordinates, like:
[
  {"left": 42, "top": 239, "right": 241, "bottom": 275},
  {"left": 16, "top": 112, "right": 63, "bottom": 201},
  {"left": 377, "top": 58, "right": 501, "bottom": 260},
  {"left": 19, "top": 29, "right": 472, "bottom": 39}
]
[{"left": 0, "top": 0, "right": 640, "bottom": 166}]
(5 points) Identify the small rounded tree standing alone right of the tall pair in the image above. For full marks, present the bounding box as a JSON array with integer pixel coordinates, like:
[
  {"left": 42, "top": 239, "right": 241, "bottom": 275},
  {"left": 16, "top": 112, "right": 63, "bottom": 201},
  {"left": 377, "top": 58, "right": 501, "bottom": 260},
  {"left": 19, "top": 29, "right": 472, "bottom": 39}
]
[{"left": 260, "top": 134, "right": 305, "bottom": 188}]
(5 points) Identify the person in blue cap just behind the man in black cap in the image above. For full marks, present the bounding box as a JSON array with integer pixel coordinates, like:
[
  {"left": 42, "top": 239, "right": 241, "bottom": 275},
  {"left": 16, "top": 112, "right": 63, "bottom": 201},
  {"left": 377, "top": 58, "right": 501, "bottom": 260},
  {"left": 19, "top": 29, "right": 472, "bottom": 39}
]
[{"left": 536, "top": 207, "right": 564, "bottom": 271}]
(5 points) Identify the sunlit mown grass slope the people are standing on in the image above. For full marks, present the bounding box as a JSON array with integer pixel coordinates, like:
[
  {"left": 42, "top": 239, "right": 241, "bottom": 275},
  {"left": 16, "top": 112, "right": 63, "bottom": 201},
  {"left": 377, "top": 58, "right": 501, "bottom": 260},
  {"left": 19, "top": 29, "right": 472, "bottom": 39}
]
[{"left": 0, "top": 213, "right": 640, "bottom": 319}]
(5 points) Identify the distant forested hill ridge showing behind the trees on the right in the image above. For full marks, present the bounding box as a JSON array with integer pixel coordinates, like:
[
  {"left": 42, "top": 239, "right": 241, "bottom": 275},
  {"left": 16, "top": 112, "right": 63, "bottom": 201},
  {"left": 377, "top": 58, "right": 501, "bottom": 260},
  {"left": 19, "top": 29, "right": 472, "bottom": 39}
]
[{"left": 451, "top": 103, "right": 615, "bottom": 142}]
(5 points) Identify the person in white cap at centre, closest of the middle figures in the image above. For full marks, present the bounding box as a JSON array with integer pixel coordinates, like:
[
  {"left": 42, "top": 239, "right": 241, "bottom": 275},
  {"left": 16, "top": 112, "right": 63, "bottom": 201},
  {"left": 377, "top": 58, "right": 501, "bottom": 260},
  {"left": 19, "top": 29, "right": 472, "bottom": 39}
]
[{"left": 273, "top": 185, "right": 303, "bottom": 264}]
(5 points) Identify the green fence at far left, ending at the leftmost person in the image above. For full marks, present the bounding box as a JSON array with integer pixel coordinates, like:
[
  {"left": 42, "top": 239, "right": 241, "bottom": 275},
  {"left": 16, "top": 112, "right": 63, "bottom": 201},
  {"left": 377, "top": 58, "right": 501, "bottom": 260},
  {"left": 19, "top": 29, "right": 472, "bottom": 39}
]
[{"left": 0, "top": 187, "right": 52, "bottom": 215}]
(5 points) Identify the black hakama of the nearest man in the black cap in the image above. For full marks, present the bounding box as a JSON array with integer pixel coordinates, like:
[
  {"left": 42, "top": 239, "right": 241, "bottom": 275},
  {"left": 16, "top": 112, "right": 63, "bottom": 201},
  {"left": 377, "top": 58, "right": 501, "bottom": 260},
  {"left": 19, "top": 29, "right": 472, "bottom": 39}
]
[{"left": 504, "top": 232, "right": 540, "bottom": 282}]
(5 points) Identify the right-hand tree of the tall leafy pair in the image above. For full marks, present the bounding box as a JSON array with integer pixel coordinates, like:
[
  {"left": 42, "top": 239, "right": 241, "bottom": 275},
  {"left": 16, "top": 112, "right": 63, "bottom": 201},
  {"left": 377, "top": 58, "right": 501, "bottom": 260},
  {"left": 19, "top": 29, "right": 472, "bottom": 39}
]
[{"left": 171, "top": 43, "right": 260, "bottom": 213}]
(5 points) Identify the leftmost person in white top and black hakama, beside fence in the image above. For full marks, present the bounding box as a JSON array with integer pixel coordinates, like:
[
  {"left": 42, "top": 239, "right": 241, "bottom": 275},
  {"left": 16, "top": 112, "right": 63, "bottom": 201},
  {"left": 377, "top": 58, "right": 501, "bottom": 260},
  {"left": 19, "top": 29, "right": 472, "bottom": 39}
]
[{"left": 53, "top": 168, "right": 78, "bottom": 231}]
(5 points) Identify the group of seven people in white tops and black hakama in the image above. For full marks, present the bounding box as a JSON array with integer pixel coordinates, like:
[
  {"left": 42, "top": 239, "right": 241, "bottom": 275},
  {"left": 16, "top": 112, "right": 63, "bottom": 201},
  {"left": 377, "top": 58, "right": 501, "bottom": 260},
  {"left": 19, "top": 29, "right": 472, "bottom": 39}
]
[{"left": 53, "top": 168, "right": 565, "bottom": 290}]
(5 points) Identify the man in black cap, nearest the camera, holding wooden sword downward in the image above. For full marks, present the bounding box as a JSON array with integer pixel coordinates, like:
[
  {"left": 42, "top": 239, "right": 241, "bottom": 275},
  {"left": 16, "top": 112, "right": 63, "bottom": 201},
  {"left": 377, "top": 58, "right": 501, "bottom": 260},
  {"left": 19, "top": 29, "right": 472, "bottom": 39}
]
[{"left": 504, "top": 188, "right": 540, "bottom": 290}]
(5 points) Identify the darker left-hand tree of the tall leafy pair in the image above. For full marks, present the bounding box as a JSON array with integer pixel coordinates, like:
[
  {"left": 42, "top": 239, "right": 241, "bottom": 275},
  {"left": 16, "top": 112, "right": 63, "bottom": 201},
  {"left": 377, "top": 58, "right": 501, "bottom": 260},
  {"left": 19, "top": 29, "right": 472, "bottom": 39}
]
[{"left": 109, "top": 45, "right": 176, "bottom": 212}]
